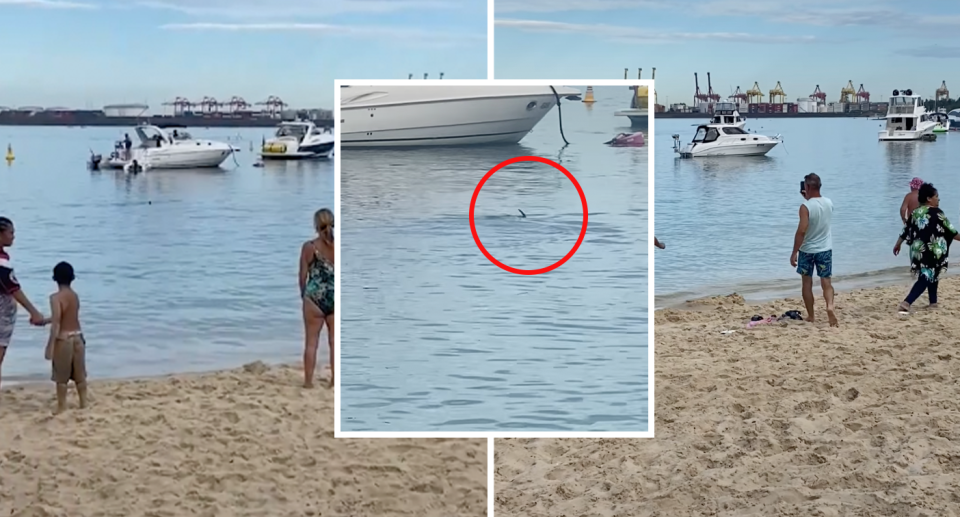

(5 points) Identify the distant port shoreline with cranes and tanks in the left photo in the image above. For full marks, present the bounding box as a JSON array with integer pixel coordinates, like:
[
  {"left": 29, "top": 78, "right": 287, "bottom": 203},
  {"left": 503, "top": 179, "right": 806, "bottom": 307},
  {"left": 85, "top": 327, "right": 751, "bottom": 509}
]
[{"left": 0, "top": 96, "right": 333, "bottom": 128}]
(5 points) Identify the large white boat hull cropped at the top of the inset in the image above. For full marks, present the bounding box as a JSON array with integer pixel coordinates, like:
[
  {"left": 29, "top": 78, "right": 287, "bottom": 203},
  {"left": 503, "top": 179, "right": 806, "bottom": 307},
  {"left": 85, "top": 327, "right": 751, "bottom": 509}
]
[{"left": 338, "top": 85, "right": 580, "bottom": 148}]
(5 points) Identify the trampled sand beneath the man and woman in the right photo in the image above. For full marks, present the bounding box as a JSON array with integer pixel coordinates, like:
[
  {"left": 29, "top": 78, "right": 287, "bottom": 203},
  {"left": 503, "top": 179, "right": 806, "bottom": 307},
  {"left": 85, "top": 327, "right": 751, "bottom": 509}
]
[{"left": 495, "top": 277, "right": 960, "bottom": 517}]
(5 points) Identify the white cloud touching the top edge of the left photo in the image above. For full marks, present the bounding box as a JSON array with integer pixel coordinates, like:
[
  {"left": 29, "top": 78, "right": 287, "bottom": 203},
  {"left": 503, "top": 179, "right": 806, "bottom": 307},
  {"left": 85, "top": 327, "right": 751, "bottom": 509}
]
[{"left": 136, "top": 0, "right": 464, "bottom": 19}]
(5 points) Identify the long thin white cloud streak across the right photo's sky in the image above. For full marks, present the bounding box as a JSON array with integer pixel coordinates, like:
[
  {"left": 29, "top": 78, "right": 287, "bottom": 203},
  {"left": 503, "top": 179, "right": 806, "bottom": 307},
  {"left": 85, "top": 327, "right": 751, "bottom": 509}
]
[{"left": 494, "top": 19, "right": 816, "bottom": 43}]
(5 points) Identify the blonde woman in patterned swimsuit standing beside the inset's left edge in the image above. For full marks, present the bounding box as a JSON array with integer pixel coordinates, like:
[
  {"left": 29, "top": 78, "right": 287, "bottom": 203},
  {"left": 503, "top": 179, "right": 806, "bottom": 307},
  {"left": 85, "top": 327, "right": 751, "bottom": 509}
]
[{"left": 300, "top": 208, "right": 334, "bottom": 388}]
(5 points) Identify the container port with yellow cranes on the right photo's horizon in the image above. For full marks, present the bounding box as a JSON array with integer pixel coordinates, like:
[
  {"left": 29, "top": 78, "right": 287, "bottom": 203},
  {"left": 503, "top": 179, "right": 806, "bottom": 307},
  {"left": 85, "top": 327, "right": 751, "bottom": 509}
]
[{"left": 638, "top": 69, "right": 956, "bottom": 118}]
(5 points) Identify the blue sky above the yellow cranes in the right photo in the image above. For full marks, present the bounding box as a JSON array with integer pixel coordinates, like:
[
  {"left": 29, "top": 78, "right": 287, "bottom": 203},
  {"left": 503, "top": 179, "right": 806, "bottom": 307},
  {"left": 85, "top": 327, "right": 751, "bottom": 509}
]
[{"left": 494, "top": 0, "right": 960, "bottom": 104}]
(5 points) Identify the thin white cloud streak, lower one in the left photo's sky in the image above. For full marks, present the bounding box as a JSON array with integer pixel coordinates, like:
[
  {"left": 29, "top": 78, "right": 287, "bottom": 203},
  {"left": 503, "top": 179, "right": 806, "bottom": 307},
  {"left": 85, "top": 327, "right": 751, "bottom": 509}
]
[{"left": 160, "top": 22, "right": 486, "bottom": 42}]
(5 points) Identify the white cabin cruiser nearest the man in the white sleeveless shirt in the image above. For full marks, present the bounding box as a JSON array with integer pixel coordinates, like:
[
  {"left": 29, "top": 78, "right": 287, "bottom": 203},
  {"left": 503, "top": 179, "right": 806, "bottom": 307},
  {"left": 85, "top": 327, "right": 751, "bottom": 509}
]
[{"left": 673, "top": 124, "right": 780, "bottom": 158}]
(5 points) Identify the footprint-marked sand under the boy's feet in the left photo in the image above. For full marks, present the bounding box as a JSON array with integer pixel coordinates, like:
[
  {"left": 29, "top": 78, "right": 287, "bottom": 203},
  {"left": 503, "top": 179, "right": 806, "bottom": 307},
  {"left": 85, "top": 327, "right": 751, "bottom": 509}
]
[{"left": 0, "top": 363, "right": 487, "bottom": 517}]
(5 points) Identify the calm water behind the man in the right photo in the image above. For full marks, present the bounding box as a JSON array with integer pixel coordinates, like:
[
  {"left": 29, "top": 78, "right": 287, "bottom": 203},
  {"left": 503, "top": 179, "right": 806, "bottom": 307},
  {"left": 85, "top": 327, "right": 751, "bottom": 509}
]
[{"left": 655, "top": 115, "right": 960, "bottom": 307}]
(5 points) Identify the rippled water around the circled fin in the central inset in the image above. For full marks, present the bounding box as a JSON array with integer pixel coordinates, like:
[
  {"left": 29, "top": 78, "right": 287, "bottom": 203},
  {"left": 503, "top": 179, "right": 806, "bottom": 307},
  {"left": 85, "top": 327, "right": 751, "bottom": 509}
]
[{"left": 340, "top": 88, "right": 648, "bottom": 431}]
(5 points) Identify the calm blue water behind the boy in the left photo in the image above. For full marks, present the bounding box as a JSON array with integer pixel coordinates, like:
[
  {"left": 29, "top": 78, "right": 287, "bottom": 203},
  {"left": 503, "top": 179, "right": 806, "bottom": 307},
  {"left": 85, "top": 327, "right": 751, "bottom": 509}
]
[{"left": 0, "top": 127, "right": 334, "bottom": 381}]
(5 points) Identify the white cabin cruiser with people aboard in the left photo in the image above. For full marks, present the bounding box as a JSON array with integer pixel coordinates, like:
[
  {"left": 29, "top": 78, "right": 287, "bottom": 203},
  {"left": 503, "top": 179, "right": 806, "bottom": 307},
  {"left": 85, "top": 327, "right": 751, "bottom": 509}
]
[{"left": 101, "top": 124, "right": 236, "bottom": 170}]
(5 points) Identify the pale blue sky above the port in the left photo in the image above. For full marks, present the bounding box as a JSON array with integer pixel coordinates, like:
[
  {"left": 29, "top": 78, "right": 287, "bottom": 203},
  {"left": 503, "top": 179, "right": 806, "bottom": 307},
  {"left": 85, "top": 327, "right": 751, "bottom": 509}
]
[{"left": 0, "top": 0, "right": 487, "bottom": 110}]
